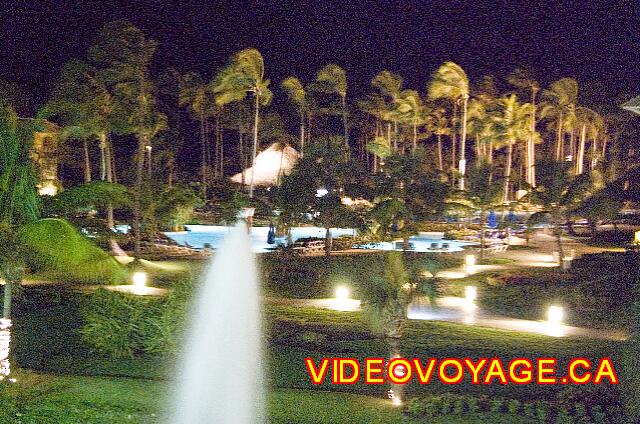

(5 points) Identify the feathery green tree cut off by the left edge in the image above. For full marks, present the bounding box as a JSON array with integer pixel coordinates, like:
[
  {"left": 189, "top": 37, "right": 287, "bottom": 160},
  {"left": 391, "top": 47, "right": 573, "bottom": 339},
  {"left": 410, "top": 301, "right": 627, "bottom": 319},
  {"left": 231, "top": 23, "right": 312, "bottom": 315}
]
[{"left": 0, "top": 100, "right": 39, "bottom": 319}]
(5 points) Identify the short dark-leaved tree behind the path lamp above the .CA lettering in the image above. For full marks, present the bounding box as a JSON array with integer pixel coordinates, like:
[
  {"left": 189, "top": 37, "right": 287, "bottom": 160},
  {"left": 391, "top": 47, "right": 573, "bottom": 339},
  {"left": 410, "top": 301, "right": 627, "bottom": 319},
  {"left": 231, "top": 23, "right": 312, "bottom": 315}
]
[{"left": 528, "top": 160, "right": 593, "bottom": 260}]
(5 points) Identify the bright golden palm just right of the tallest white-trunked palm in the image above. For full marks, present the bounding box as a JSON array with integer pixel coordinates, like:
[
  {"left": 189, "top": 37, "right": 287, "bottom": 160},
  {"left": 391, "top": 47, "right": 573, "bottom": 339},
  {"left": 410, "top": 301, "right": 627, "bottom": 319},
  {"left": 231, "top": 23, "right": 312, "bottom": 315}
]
[{"left": 494, "top": 94, "right": 532, "bottom": 203}]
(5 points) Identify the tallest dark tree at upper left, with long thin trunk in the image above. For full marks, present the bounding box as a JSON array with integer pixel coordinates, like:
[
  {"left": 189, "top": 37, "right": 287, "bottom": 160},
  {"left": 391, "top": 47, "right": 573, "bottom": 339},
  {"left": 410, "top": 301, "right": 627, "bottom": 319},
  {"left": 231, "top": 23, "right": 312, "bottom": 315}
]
[{"left": 90, "top": 21, "right": 167, "bottom": 259}]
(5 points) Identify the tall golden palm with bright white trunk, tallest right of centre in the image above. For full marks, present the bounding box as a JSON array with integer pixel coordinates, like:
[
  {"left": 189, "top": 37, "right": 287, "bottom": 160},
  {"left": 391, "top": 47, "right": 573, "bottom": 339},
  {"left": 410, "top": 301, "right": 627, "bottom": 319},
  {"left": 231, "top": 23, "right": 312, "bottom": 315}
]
[{"left": 427, "top": 62, "right": 469, "bottom": 190}]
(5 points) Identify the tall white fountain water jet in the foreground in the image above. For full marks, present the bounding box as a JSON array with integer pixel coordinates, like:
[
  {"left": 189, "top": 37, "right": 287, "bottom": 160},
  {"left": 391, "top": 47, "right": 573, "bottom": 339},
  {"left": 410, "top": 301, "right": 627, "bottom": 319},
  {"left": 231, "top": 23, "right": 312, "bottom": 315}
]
[{"left": 170, "top": 224, "right": 264, "bottom": 424}]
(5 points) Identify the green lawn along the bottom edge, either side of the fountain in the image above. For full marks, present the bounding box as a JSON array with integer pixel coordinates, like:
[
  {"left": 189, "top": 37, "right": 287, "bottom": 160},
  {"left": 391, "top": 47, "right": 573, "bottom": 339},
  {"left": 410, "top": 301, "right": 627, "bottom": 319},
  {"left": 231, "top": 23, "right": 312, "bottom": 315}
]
[{"left": 0, "top": 373, "right": 528, "bottom": 424}]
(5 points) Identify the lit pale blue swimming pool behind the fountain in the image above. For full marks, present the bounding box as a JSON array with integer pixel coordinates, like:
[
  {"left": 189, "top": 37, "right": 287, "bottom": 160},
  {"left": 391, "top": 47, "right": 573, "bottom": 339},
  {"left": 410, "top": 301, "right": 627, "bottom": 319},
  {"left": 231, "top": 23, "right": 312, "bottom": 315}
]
[{"left": 165, "top": 225, "right": 473, "bottom": 253}]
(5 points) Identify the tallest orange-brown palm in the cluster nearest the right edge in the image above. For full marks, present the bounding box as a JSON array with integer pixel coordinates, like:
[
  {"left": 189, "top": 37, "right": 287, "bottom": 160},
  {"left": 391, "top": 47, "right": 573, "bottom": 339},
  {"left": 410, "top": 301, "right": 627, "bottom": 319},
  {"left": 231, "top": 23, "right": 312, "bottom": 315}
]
[{"left": 540, "top": 78, "right": 578, "bottom": 160}]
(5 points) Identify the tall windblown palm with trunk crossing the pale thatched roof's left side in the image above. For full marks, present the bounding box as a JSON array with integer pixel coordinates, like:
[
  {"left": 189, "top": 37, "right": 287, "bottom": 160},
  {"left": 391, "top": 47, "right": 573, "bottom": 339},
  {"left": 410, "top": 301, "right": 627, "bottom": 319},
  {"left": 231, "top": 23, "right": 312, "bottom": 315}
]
[{"left": 213, "top": 48, "right": 273, "bottom": 198}]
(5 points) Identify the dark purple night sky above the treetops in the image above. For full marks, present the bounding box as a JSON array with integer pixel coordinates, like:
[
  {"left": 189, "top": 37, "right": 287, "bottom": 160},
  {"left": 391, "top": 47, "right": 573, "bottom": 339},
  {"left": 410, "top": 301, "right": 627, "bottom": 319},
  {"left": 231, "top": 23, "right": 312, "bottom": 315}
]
[{"left": 0, "top": 0, "right": 640, "bottom": 112}]
